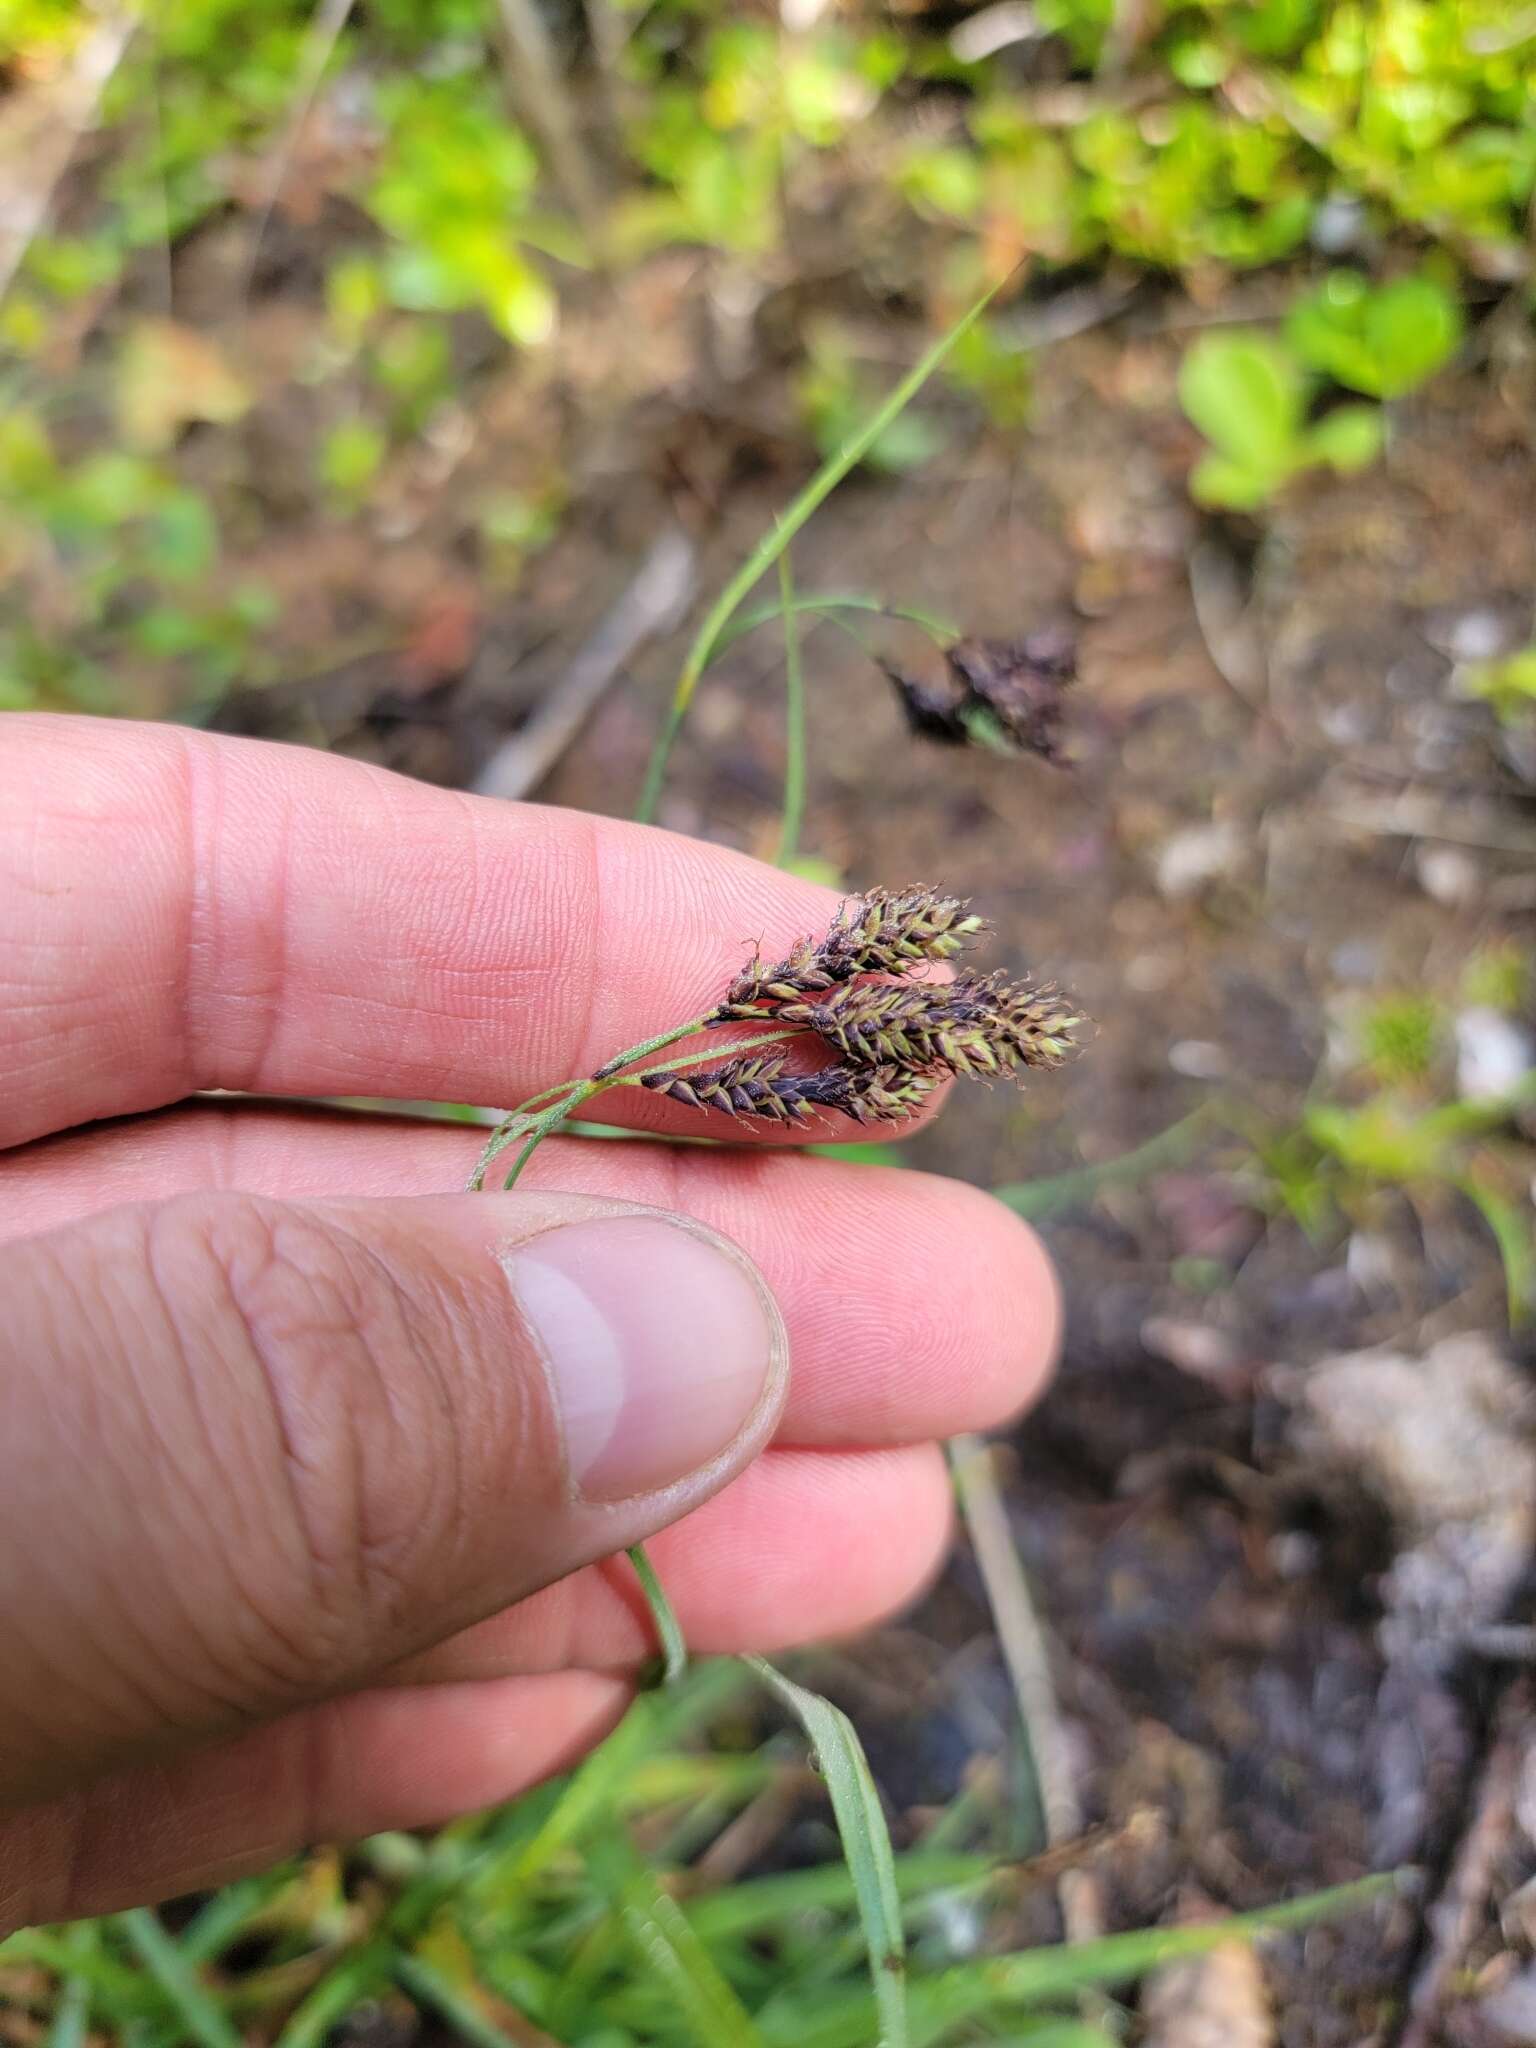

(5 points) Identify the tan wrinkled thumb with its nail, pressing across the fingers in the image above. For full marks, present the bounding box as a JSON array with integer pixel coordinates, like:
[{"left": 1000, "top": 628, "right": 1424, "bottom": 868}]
[{"left": 0, "top": 1194, "right": 786, "bottom": 1804}]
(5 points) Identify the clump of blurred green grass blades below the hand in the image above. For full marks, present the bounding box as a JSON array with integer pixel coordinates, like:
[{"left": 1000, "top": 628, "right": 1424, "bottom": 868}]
[{"left": 0, "top": 1659, "right": 1391, "bottom": 2048}]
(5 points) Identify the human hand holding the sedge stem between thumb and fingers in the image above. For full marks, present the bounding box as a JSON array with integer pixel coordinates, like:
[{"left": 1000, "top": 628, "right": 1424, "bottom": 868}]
[{"left": 0, "top": 715, "right": 1057, "bottom": 1931}]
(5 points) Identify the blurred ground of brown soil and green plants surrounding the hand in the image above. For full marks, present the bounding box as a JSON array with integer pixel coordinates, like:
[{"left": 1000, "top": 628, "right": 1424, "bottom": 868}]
[{"left": 0, "top": 0, "right": 1536, "bottom": 2048}]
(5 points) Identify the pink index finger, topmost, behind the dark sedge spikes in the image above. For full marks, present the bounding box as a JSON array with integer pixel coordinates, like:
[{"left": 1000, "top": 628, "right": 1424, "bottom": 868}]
[{"left": 0, "top": 713, "right": 925, "bottom": 1145}]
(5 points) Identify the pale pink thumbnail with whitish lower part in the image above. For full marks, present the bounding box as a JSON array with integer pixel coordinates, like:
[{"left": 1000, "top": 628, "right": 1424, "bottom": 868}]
[{"left": 502, "top": 1217, "right": 784, "bottom": 1501}]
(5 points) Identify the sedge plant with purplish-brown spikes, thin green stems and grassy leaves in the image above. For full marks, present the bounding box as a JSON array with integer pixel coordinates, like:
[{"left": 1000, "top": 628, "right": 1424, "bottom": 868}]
[{"left": 0, "top": 280, "right": 1393, "bottom": 2048}]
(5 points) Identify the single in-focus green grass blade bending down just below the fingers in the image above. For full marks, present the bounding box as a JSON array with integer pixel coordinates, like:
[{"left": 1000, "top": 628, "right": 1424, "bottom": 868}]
[{"left": 741, "top": 1657, "right": 909, "bottom": 2048}]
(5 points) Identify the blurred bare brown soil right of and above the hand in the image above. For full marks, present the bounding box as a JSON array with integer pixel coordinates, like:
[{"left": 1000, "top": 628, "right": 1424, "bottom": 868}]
[{"left": 207, "top": 262, "right": 1536, "bottom": 2048}]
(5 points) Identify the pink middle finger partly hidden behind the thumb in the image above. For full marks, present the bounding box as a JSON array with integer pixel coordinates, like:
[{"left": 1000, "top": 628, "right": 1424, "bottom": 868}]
[{"left": 0, "top": 1104, "right": 1061, "bottom": 1446}]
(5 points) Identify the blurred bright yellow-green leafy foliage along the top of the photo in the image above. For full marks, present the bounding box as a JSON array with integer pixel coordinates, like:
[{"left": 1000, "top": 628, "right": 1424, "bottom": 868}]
[{"left": 0, "top": 0, "right": 1536, "bottom": 715}]
